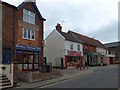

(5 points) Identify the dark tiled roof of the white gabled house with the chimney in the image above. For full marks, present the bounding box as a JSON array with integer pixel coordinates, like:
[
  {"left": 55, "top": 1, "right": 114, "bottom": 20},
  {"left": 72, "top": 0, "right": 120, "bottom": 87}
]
[{"left": 58, "top": 31, "right": 82, "bottom": 43}]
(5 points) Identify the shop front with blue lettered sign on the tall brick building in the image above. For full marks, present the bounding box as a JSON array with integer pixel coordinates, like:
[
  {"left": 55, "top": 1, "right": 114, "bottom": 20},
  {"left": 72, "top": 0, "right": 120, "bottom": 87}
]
[{"left": 16, "top": 45, "right": 40, "bottom": 71}]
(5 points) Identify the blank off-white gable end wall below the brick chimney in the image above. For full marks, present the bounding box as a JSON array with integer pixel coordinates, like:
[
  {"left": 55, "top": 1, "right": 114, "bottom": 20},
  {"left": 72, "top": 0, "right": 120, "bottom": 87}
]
[{"left": 44, "top": 30, "right": 65, "bottom": 66}]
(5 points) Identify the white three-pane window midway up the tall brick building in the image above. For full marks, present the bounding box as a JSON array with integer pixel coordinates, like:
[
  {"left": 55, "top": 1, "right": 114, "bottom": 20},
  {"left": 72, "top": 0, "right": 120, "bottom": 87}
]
[{"left": 23, "top": 28, "right": 35, "bottom": 40}]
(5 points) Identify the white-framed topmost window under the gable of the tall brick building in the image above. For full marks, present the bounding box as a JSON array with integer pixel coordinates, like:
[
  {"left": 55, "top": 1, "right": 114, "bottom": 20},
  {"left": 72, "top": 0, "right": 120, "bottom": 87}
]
[{"left": 23, "top": 9, "right": 35, "bottom": 24}]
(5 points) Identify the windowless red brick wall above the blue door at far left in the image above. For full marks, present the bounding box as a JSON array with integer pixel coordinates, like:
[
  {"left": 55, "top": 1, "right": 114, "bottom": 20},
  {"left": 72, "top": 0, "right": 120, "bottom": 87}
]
[{"left": 2, "top": 4, "right": 14, "bottom": 48}]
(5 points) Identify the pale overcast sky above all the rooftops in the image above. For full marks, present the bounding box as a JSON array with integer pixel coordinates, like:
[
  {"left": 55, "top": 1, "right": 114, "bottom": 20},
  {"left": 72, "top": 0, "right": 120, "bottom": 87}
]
[{"left": 3, "top": 0, "right": 119, "bottom": 43}]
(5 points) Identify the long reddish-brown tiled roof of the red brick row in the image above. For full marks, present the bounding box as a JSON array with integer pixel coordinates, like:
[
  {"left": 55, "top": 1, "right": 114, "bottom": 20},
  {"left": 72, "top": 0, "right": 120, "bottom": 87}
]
[{"left": 69, "top": 31, "right": 105, "bottom": 48}]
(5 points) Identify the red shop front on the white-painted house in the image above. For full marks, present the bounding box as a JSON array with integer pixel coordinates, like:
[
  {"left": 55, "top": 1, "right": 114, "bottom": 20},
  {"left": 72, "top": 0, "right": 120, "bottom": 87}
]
[{"left": 65, "top": 50, "right": 82, "bottom": 69}]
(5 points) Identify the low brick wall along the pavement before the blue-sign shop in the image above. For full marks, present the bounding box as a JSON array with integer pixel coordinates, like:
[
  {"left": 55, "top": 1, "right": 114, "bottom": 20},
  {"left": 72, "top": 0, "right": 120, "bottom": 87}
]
[{"left": 17, "top": 70, "right": 63, "bottom": 83}]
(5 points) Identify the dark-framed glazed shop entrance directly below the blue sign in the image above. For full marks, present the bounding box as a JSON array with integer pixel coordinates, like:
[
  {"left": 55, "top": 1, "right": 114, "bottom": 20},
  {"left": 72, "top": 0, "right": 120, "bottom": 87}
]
[{"left": 16, "top": 51, "right": 38, "bottom": 71}]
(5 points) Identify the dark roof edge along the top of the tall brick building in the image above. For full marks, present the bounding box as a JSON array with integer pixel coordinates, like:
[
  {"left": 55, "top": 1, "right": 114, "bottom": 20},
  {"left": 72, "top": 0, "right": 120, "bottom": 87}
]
[{"left": 0, "top": 0, "right": 46, "bottom": 21}]
